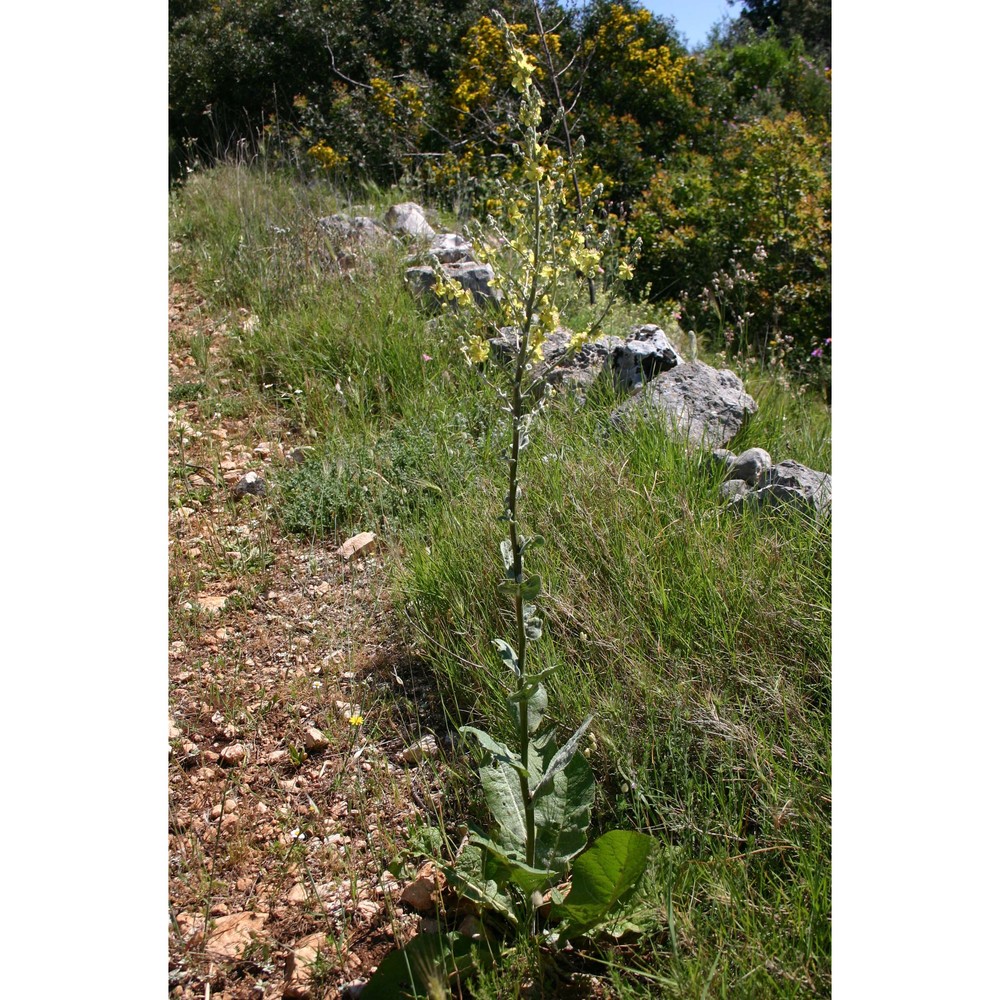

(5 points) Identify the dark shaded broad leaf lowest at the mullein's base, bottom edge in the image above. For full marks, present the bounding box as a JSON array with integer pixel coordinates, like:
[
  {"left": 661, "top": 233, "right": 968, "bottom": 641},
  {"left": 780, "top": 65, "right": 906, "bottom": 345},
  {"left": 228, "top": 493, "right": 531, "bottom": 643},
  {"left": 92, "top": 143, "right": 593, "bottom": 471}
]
[{"left": 361, "top": 931, "right": 494, "bottom": 1000}]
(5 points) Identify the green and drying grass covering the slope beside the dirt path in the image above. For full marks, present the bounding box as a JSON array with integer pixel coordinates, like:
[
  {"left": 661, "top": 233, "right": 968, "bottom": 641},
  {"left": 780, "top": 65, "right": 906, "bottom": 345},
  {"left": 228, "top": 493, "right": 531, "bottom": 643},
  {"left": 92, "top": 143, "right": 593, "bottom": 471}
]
[{"left": 172, "top": 160, "right": 831, "bottom": 998}]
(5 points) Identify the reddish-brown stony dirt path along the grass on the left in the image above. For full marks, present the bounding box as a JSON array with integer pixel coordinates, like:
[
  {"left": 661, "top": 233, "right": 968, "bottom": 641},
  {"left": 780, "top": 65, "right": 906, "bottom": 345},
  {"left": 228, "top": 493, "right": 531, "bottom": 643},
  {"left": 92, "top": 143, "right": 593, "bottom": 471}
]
[{"left": 169, "top": 285, "right": 448, "bottom": 1000}]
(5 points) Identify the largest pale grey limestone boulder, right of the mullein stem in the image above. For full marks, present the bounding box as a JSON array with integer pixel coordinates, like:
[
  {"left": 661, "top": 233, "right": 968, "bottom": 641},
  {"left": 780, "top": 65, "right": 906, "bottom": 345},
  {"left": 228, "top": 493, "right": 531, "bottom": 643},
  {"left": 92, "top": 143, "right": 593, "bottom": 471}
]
[{"left": 611, "top": 361, "right": 757, "bottom": 448}]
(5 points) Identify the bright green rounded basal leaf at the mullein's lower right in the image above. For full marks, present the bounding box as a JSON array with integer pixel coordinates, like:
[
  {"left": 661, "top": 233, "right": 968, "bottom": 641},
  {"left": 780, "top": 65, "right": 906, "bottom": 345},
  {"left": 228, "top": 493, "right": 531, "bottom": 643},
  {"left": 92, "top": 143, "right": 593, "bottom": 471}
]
[{"left": 549, "top": 830, "right": 653, "bottom": 940}]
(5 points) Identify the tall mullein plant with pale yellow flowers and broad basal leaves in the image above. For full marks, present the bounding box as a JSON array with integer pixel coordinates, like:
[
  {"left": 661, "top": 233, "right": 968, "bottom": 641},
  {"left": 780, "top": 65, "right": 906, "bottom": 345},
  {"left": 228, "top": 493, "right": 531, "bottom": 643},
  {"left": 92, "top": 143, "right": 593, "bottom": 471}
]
[{"left": 437, "top": 22, "right": 649, "bottom": 941}]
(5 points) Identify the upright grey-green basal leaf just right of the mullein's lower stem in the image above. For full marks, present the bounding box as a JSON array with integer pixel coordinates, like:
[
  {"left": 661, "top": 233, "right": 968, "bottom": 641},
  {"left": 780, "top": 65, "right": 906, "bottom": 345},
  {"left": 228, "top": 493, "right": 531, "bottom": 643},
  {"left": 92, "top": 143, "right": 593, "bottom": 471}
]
[{"left": 528, "top": 732, "right": 594, "bottom": 872}]
